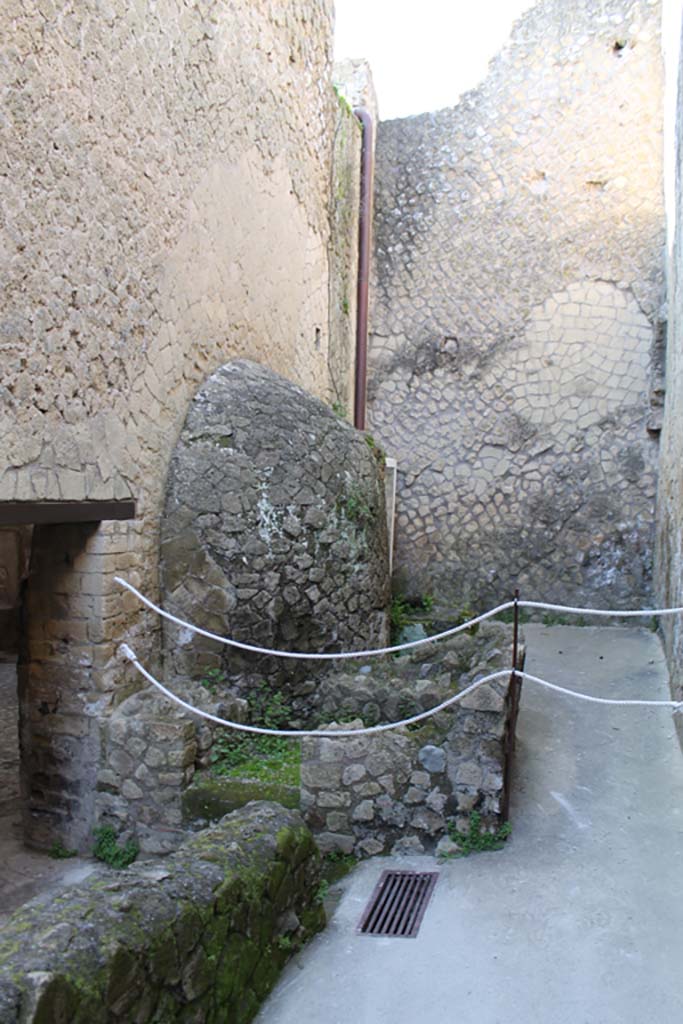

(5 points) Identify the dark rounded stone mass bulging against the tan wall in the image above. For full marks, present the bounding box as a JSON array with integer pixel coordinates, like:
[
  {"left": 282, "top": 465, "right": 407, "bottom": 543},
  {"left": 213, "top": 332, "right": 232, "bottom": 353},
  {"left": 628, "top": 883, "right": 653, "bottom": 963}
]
[{"left": 161, "top": 360, "right": 389, "bottom": 685}]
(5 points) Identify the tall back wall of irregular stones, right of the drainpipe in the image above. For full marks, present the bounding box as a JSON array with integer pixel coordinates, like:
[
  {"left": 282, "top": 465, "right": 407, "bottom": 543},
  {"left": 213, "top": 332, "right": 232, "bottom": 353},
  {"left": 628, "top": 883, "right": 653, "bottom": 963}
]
[{"left": 370, "top": 0, "right": 664, "bottom": 606}]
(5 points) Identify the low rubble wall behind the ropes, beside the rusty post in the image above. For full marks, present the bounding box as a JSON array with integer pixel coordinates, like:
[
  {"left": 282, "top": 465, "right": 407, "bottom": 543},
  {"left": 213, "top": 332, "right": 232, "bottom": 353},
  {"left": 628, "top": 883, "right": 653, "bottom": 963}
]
[{"left": 301, "top": 623, "right": 512, "bottom": 857}]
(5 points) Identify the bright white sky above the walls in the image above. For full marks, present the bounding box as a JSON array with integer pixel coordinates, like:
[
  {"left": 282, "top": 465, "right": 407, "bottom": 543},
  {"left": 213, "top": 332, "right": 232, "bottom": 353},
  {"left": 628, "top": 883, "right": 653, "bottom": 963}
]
[{"left": 335, "top": 0, "right": 536, "bottom": 120}]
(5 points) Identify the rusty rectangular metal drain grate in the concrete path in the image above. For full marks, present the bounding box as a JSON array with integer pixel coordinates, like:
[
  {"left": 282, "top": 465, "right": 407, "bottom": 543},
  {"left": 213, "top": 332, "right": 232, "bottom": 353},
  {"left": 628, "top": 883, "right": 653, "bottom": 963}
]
[{"left": 358, "top": 871, "right": 438, "bottom": 939}]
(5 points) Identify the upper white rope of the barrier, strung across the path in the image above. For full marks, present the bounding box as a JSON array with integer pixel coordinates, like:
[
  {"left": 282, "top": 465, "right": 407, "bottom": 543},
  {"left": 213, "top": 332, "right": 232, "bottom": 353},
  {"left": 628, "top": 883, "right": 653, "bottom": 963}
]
[{"left": 114, "top": 577, "right": 683, "bottom": 662}]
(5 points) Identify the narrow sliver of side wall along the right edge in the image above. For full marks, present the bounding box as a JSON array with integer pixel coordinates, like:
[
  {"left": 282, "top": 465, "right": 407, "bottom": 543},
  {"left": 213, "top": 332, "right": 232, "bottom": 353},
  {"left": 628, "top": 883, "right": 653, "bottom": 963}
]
[{"left": 656, "top": 2, "right": 683, "bottom": 724}]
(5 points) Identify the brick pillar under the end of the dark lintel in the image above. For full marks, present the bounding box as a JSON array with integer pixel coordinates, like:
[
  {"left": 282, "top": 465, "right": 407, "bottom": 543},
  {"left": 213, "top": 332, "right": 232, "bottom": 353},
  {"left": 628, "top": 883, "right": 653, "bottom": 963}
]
[{"left": 18, "top": 523, "right": 106, "bottom": 850}]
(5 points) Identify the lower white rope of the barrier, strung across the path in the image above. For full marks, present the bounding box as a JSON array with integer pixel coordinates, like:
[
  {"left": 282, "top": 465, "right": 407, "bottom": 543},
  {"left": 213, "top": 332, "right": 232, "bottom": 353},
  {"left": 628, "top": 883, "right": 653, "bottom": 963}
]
[{"left": 120, "top": 643, "right": 683, "bottom": 739}]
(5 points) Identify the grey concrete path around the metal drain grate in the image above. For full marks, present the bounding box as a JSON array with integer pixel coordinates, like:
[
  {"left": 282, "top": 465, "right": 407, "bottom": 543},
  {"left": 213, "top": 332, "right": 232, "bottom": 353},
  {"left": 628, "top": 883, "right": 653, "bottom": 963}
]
[{"left": 253, "top": 626, "right": 683, "bottom": 1024}]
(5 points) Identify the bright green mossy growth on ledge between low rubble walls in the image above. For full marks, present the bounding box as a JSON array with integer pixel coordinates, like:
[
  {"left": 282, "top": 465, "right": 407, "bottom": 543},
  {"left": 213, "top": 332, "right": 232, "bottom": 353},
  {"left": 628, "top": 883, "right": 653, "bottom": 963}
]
[{"left": 211, "top": 682, "right": 301, "bottom": 785}]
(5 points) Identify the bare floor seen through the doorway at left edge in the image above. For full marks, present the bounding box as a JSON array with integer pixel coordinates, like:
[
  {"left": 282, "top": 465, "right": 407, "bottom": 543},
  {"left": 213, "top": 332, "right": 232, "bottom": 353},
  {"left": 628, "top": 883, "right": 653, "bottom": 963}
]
[{"left": 0, "top": 659, "right": 94, "bottom": 926}]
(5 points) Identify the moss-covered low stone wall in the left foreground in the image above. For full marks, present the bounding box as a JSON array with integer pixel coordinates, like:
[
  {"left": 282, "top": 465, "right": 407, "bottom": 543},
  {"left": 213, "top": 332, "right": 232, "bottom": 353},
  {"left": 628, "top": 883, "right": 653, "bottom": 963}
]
[{"left": 0, "top": 803, "right": 325, "bottom": 1024}]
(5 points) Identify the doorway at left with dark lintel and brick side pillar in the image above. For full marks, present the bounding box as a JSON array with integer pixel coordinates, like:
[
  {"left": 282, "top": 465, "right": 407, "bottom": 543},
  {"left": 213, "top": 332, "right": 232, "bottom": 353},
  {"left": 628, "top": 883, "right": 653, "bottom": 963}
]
[{"left": 0, "top": 502, "right": 134, "bottom": 897}]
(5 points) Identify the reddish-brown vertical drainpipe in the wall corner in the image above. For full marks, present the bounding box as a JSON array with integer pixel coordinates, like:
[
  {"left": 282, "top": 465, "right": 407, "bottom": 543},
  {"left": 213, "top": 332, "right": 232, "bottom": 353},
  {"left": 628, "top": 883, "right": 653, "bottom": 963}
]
[{"left": 353, "top": 106, "right": 375, "bottom": 430}]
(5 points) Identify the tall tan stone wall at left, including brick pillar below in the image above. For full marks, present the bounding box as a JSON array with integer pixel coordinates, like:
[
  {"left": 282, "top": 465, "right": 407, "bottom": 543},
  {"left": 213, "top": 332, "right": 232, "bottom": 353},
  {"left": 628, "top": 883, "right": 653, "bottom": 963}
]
[{"left": 0, "top": 0, "right": 357, "bottom": 847}]
